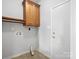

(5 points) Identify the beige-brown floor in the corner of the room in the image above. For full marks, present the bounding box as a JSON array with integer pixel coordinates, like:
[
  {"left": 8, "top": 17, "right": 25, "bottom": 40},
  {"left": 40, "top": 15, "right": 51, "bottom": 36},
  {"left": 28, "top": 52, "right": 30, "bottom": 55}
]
[{"left": 12, "top": 51, "right": 49, "bottom": 59}]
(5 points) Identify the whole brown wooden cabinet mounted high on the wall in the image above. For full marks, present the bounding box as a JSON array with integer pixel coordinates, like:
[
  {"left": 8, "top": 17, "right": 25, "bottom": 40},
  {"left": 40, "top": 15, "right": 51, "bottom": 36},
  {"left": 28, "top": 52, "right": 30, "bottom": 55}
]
[{"left": 23, "top": 0, "right": 40, "bottom": 27}]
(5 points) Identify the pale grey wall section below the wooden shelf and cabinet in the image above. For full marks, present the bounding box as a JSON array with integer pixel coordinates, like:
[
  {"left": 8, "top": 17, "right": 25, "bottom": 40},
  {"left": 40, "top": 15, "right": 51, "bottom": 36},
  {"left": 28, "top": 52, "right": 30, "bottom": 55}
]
[{"left": 2, "top": 22, "right": 39, "bottom": 58}]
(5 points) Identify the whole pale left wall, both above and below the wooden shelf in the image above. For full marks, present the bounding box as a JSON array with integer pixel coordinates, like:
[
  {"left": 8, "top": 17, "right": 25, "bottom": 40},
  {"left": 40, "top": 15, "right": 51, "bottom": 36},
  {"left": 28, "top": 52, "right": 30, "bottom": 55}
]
[{"left": 2, "top": 0, "right": 39, "bottom": 59}]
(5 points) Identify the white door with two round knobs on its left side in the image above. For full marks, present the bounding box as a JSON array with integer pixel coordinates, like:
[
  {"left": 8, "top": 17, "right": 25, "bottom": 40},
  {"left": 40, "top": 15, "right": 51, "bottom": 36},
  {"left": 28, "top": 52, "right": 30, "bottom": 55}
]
[{"left": 51, "top": 3, "right": 70, "bottom": 59}]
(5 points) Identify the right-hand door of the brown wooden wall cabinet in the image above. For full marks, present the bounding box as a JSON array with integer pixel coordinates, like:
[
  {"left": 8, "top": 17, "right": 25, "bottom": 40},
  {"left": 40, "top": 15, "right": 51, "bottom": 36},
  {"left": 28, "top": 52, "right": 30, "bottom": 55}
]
[{"left": 32, "top": 5, "right": 40, "bottom": 27}]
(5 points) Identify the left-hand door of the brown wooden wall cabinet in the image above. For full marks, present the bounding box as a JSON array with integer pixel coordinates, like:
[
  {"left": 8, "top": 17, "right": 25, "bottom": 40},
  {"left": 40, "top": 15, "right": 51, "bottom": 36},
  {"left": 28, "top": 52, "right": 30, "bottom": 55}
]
[{"left": 26, "top": 2, "right": 34, "bottom": 26}]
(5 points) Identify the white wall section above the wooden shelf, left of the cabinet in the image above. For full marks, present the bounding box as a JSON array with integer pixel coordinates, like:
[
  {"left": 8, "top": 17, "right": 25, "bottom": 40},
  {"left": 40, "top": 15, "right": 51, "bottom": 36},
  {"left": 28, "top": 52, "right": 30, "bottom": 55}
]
[{"left": 2, "top": 0, "right": 23, "bottom": 19}]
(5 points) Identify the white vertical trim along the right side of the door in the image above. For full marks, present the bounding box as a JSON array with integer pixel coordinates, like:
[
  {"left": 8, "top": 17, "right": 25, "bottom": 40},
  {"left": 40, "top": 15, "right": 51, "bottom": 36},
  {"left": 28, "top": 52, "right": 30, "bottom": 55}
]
[{"left": 70, "top": 0, "right": 76, "bottom": 59}]
